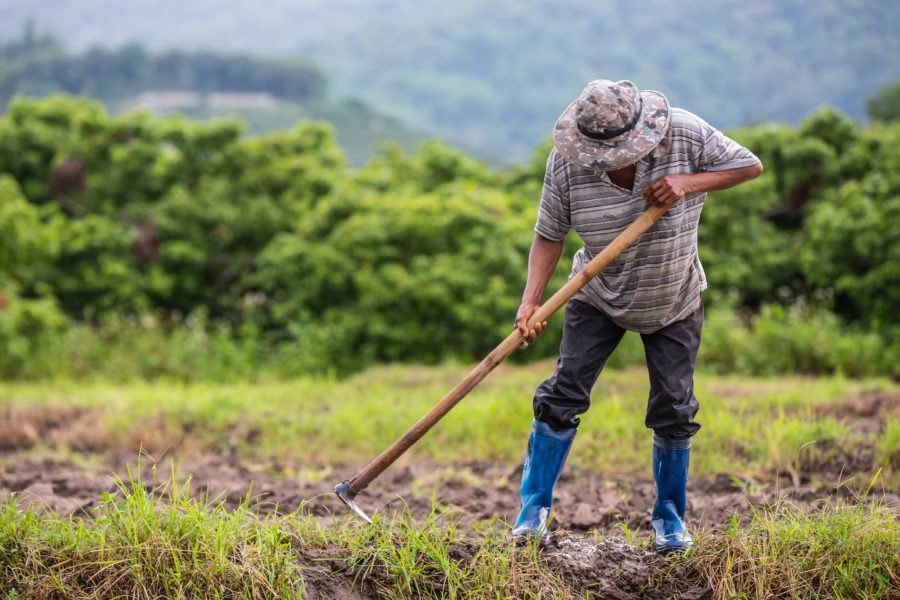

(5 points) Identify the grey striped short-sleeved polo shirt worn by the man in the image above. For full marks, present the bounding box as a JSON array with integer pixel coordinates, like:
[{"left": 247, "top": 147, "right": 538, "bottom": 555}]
[{"left": 534, "top": 108, "right": 759, "bottom": 333}]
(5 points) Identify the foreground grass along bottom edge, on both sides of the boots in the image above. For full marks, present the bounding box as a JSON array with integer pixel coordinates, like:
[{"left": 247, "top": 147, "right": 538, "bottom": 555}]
[{"left": 0, "top": 472, "right": 900, "bottom": 600}]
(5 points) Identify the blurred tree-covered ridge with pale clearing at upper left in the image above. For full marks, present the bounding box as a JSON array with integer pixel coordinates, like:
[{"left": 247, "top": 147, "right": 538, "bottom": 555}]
[{"left": 0, "top": 27, "right": 421, "bottom": 165}]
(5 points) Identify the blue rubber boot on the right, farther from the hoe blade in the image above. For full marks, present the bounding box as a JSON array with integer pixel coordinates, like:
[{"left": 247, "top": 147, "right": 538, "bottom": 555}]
[{"left": 651, "top": 435, "right": 694, "bottom": 554}]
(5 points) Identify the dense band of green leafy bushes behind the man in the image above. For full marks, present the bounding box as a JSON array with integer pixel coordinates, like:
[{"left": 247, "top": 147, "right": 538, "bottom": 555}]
[{"left": 0, "top": 97, "right": 900, "bottom": 376}]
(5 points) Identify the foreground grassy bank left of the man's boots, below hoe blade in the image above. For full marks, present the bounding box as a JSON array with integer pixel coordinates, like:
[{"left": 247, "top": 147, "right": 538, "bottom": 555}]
[{"left": 0, "top": 474, "right": 571, "bottom": 599}]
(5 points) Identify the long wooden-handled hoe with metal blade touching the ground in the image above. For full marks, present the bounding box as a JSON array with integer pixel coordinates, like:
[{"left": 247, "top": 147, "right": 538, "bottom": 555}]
[{"left": 334, "top": 206, "right": 669, "bottom": 523}]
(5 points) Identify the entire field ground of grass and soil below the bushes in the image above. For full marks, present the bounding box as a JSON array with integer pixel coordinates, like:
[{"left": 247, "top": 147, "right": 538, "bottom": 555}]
[{"left": 0, "top": 362, "right": 900, "bottom": 598}]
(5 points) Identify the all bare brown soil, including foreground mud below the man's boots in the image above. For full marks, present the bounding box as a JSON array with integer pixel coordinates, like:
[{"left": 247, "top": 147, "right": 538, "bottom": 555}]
[{"left": 0, "top": 393, "right": 900, "bottom": 598}]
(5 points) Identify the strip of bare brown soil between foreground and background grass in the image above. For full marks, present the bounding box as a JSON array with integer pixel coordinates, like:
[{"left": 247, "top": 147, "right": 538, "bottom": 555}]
[{"left": 0, "top": 392, "right": 900, "bottom": 534}]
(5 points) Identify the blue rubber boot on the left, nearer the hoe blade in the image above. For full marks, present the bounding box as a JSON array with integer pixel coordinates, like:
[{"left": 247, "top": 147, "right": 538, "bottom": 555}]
[{"left": 512, "top": 419, "right": 577, "bottom": 538}]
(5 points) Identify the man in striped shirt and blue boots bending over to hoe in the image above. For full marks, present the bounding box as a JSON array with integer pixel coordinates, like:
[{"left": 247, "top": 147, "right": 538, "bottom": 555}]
[{"left": 512, "top": 80, "right": 762, "bottom": 553}]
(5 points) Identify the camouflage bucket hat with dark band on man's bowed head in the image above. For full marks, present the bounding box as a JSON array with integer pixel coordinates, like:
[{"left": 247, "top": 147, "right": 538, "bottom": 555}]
[{"left": 553, "top": 79, "right": 672, "bottom": 171}]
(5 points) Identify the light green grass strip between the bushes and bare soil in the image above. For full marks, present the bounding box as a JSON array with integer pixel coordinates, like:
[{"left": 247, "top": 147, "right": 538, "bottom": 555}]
[{"left": 0, "top": 362, "right": 900, "bottom": 482}]
